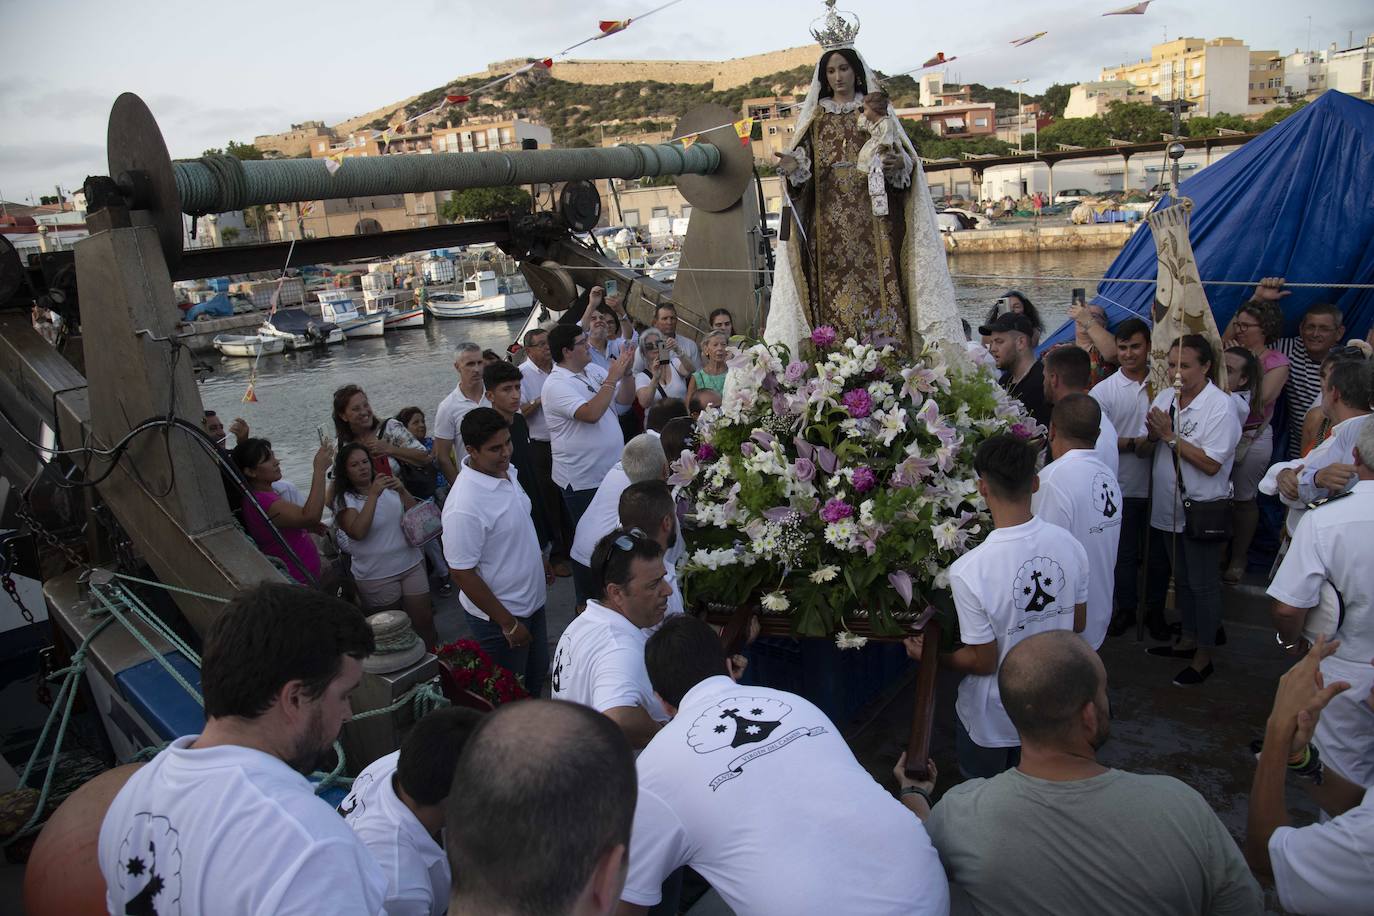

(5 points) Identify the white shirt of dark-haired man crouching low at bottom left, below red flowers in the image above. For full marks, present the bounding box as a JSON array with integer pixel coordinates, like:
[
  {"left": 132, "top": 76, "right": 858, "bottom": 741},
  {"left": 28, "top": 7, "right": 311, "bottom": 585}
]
[{"left": 339, "top": 751, "right": 452, "bottom": 916}]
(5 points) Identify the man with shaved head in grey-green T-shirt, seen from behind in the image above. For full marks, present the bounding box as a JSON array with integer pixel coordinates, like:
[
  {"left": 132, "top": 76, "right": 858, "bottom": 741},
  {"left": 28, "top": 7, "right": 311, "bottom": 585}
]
[{"left": 926, "top": 630, "right": 1263, "bottom": 916}]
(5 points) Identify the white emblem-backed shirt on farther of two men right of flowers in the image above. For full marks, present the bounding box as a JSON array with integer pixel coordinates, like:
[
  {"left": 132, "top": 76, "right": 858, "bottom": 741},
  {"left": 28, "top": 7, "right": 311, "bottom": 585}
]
[{"left": 1031, "top": 449, "right": 1123, "bottom": 650}]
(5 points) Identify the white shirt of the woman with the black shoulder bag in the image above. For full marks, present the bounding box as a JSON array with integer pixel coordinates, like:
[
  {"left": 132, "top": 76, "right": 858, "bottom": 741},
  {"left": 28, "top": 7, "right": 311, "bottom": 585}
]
[{"left": 1150, "top": 382, "right": 1241, "bottom": 531}]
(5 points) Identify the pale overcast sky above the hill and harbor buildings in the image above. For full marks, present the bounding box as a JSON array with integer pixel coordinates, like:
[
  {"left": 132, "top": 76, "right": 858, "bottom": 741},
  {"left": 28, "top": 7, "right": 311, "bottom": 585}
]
[{"left": 0, "top": 0, "right": 1374, "bottom": 201}]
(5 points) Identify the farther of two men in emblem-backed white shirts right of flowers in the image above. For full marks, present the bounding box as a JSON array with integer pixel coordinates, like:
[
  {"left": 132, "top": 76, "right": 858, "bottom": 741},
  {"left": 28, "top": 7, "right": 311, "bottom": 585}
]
[{"left": 1031, "top": 395, "right": 1121, "bottom": 650}]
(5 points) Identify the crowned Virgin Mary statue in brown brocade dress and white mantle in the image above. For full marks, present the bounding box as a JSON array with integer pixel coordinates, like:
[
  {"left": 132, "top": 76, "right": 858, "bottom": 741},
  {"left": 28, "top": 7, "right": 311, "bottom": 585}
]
[{"left": 764, "top": 0, "right": 963, "bottom": 354}]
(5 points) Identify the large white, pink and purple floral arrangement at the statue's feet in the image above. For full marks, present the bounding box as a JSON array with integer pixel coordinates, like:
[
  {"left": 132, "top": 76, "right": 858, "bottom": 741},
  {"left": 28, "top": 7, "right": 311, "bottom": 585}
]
[{"left": 669, "top": 327, "right": 1040, "bottom": 648}]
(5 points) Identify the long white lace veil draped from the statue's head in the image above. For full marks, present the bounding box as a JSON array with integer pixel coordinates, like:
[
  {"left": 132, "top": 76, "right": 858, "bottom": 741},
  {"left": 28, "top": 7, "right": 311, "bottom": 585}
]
[{"left": 764, "top": 51, "right": 963, "bottom": 353}]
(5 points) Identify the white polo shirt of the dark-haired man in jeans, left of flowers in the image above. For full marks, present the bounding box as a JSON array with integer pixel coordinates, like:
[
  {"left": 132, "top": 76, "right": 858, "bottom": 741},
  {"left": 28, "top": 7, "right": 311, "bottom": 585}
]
[{"left": 444, "top": 459, "right": 548, "bottom": 621}]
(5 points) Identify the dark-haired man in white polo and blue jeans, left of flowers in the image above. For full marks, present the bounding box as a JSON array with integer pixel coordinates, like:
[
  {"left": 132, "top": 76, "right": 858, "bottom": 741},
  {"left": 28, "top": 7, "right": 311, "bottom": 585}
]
[{"left": 444, "top": 407, "right": 554, "bottom": 696}]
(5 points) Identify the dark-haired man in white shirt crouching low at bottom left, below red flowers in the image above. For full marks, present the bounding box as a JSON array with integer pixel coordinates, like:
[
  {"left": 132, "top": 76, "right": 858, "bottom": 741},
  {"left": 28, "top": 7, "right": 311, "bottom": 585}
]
[{"left": 339, "top": 706, "right": 482, "bottom": 916}]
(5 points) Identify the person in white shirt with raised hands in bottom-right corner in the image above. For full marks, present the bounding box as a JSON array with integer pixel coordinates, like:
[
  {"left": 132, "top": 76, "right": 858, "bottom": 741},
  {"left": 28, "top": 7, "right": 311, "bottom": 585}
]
[{"left": 1245, "top": 637, "right": 1374, "bottom": 916}]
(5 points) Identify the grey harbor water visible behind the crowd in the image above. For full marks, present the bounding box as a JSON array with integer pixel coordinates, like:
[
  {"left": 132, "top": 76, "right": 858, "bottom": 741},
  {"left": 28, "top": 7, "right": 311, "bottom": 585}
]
[{"left": 201, "top": 250, "right": 1116, "bottom": 489}]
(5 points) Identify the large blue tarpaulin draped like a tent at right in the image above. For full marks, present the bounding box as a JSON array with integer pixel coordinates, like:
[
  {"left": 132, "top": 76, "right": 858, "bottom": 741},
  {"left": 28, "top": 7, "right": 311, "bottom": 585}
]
[{"left": 1041, "top": 89, "right": 1374, "bottom": 349}]
